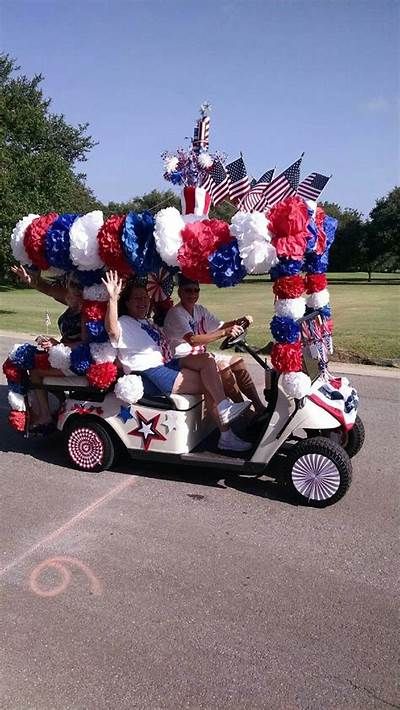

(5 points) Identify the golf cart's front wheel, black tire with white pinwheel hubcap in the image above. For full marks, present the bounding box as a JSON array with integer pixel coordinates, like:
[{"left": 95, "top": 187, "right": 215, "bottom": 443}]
[{"left": 286, "top": 436, "right": 352, "bottom": 508}]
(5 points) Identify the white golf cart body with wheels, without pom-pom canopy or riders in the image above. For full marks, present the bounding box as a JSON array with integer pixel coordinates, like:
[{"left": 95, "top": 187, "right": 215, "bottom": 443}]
[{"left": 39, "top": 314, "right": 364, "bottom": 506}]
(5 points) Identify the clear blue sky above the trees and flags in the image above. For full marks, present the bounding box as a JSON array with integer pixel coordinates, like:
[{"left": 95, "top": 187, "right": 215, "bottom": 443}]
[{"left": 0, "top": 0, "right": 400, "bottom": 216}]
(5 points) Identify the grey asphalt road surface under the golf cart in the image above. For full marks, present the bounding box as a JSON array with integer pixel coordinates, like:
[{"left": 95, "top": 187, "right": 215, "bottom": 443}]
[{"left": 0, "top": 338, "right": 399, "bottom": 710}]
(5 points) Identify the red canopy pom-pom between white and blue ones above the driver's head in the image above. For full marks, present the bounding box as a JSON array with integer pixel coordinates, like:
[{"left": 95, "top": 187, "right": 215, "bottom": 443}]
[{"left": 178, "top": 219, "right": 232, "bottom": 283}]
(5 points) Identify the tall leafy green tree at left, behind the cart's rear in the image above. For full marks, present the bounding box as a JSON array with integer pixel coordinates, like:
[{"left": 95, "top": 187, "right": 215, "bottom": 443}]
[{"left": 0, "top": 54, "right": 99, "bottom": 277}]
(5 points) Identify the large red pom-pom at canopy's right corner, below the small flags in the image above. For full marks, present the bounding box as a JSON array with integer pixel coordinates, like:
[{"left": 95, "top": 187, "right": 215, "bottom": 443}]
[{"left": 268, "top": 197, "right": 308, "bottom": 259}]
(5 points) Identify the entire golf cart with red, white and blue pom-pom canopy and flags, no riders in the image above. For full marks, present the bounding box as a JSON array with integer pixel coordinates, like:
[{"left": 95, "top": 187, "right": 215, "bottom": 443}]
[{"left": 3, "top": 106, "right": 364, "bottom": 505}]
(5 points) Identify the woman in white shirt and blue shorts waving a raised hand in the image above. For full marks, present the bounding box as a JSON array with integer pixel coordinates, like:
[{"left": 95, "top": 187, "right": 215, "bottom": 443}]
[{"left": 103, "top": 271, "right": 251, "bottom": 451}]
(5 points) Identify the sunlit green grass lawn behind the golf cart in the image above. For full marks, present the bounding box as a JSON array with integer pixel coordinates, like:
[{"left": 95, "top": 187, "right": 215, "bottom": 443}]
[{"left": 0, "top": 273, "right": 400, "bottom": 358}]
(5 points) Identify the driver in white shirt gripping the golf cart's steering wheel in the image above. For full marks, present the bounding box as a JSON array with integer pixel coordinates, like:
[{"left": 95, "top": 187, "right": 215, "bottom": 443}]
[{"left": 164, "top": 274, "right": 265, "bottom": 414}]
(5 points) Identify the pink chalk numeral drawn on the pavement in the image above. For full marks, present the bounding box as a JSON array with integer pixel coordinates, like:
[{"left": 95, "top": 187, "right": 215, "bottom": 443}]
[{"left": 29, "top": 557, "right": 102, "bottom": 597}]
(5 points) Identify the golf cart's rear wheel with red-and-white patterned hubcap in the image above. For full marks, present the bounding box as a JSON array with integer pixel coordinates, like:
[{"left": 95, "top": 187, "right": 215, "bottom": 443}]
[{"left": 64, "top": 421, "right": 115, "bottom": 473}]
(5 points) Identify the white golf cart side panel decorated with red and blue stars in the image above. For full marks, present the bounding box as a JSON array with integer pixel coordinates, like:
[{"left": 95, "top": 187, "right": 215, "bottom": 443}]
[{"left": 57, "top": 393, "right": 215, "bottom": 454}]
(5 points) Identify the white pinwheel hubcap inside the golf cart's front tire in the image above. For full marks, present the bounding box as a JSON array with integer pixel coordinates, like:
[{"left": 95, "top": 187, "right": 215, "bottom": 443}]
[{"left": 292, "top": 454, "right": 340, "bottom": 500}]
